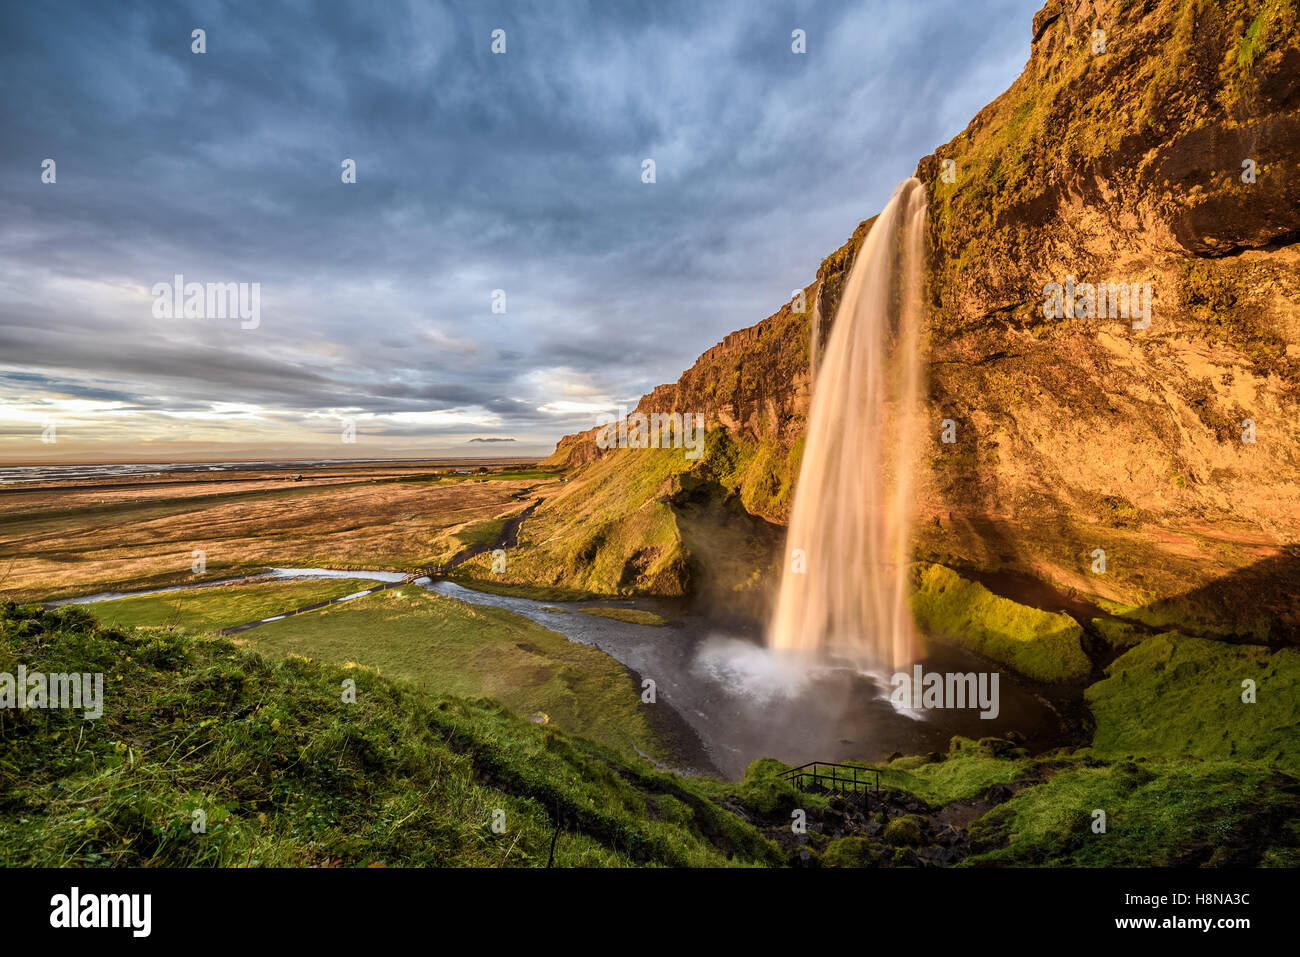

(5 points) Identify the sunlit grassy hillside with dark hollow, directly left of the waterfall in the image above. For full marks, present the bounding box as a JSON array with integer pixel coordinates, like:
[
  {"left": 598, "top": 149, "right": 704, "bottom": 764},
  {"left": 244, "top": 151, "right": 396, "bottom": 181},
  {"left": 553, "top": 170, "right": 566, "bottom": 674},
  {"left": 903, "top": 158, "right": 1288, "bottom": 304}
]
[{"left": 455, "top": 428, "right": 785, "bottom": 624}]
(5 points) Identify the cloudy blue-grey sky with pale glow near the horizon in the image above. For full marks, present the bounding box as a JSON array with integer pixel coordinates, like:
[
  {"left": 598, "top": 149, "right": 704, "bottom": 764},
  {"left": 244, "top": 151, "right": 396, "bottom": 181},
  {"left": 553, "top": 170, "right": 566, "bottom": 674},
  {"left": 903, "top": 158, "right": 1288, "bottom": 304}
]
[{"left": 0, "top": 0, "right": 1040, "bottom": 464}]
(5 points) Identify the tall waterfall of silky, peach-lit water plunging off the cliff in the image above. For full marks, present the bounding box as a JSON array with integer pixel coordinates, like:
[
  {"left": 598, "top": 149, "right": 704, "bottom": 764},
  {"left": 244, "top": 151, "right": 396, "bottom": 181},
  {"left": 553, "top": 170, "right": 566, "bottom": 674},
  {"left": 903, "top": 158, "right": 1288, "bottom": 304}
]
[{"left": 768, "top": 178, "right": 926, "bottom": 668}]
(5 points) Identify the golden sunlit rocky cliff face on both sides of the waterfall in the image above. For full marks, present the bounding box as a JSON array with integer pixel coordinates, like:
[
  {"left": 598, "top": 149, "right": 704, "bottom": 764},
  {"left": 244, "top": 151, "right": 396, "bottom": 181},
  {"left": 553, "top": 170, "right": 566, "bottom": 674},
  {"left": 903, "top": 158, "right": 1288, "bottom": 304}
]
[{"left": 555, "top": 0, "right": 1300, "bottom": 637}]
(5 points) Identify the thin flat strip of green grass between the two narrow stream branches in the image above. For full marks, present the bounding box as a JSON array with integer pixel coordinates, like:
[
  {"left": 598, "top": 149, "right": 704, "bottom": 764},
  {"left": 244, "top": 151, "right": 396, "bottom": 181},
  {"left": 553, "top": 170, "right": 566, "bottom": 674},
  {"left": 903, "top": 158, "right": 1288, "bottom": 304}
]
[{"left": 63, "top": 579, "right": 376, "bottom": 632}]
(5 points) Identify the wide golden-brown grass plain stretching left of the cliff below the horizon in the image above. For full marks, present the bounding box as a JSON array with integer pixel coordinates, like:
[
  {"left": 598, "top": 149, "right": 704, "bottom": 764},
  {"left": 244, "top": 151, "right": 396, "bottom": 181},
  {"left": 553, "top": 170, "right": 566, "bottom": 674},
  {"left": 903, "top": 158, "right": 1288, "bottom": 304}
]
[{"left": 0, "top": 473, "right": 538, "bottom": 601}]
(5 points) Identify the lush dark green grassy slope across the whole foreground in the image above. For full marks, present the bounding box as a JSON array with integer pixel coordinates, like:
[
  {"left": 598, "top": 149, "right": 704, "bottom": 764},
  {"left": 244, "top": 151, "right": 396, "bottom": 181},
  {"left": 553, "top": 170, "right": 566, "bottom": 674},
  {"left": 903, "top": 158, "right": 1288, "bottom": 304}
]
[{"left": 0, "top": 595, "right": 1300, "bottom": 866}]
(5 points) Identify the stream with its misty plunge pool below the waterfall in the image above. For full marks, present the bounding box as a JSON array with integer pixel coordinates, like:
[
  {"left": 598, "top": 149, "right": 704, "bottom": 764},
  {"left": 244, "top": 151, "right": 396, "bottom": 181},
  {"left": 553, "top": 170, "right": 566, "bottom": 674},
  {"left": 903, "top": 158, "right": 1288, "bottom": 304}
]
[{"left": 49, "top": 568, "right": 1069, "bottom": 779}]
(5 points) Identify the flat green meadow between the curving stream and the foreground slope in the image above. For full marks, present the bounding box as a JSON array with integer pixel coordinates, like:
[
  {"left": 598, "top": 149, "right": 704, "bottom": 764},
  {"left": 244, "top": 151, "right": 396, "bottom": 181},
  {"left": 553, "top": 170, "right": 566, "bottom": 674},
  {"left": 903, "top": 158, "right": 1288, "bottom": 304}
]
[{"left": 241, "top": 588, "right": 672, "bottom": 761}]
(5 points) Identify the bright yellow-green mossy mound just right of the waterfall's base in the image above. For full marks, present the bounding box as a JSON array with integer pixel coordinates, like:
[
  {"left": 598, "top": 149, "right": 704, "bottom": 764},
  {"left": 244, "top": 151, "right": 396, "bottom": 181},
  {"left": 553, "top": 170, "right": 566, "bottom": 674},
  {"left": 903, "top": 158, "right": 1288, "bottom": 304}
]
[{"left": 911, "top": 564, "right": 1091, "bottom": 681}]
